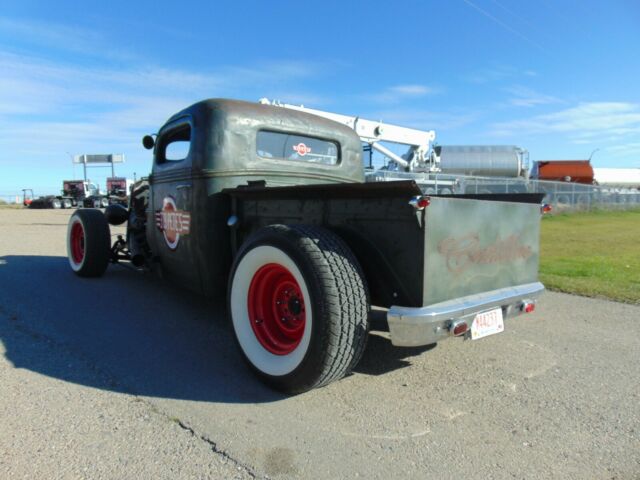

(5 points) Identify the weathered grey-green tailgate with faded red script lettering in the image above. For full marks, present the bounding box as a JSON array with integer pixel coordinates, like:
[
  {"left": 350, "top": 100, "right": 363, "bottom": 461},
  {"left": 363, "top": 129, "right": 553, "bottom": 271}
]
[{"left": 423, "top": 197, "right": 540, "bottom": 306}]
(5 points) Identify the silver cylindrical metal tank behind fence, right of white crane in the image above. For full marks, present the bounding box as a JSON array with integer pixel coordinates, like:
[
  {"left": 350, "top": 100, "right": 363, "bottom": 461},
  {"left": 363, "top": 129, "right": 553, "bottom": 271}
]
[{"left": 434, "top": 145, "right": 529, "bottom": 177}]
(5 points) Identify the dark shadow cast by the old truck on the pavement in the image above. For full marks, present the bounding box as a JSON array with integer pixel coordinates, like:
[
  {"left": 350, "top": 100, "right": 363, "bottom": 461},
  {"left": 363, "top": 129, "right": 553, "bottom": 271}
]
[{"left": 0, "top": 256, "right": 432, "bottom": 403}]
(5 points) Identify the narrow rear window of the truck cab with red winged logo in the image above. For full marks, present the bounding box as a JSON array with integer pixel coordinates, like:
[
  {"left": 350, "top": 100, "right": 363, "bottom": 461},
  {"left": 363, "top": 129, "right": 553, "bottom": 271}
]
[{"left": 256, "top": 131, "right": 340, "bottom": 165}]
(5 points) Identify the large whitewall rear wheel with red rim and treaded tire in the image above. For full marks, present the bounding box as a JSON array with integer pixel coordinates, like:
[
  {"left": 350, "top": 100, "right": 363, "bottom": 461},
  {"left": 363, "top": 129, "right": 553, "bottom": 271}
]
[{"left": 228, "top": 225, "right": 369, "bottom": 393}]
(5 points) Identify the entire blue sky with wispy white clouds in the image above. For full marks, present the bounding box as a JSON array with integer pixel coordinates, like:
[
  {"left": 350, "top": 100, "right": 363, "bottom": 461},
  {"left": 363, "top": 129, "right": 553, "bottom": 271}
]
[{"left": 0, "top": 0, "right": 640, "bottom": 195}]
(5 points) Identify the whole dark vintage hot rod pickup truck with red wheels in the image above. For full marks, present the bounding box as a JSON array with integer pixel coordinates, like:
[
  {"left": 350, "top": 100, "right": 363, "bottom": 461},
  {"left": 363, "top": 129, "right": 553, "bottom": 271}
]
[{"left": 67, "top": 99, "right": 544, "bottom": 393}]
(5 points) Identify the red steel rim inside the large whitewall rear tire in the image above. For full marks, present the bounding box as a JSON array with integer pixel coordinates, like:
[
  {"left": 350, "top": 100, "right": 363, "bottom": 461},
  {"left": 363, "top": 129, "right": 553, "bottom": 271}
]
[{"left": 248, "top": 263, "right": 306, "bottom": 355}]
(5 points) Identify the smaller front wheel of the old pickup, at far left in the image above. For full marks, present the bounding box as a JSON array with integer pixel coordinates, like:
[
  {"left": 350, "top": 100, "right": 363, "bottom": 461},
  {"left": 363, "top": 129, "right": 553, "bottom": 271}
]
[{"left": 67, "top": 209, "right": 111, "bottom": 277}]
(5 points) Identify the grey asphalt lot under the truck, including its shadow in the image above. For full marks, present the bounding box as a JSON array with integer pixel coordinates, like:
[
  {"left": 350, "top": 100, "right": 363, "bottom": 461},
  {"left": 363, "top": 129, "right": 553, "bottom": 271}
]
[{"left": 0, "top": 209, "right": 640, "bottom": 479}]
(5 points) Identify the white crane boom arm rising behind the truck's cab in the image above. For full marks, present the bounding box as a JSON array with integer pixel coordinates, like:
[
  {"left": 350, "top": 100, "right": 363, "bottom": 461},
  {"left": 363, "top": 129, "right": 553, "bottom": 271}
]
[{"left": 259, "top": 98, "right": 440, "bottom": 172}]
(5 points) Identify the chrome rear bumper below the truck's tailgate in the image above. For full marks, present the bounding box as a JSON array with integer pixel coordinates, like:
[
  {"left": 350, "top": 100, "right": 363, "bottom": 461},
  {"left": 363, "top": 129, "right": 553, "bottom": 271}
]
[{"left": 387, "top": 282, "right": 544, "bottom": 347}]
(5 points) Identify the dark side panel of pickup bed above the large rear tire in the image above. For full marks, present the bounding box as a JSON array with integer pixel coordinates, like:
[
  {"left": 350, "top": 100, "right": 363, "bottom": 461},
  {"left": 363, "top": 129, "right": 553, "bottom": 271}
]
[{"left": 225, "top": 182, "right": 424, "bottom": 306}]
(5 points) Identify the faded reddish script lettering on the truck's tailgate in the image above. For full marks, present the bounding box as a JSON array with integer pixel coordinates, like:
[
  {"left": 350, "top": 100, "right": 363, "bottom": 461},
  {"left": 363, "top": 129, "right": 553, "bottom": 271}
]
[{"left": 438, "top": 233, "right": 533, "bottom": 275}]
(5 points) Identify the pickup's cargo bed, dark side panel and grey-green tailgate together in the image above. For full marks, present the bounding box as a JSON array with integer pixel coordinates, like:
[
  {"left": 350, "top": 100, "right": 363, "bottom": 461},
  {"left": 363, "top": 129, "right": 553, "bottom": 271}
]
[{"left": 224, "top": 181, "right": 542, "bottom": 308}]
